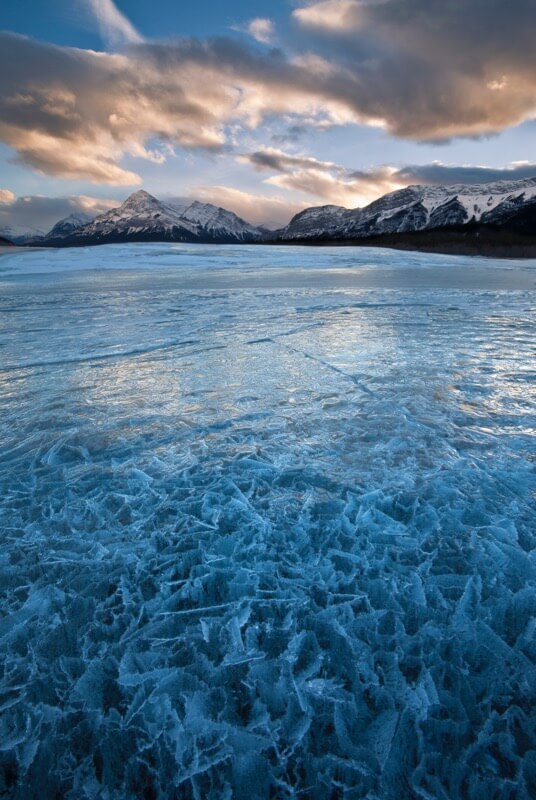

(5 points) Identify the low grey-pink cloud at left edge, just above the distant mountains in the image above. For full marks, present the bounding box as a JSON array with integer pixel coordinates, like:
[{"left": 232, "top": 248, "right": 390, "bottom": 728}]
[{"left": 0, "top": 192, "right": 119, "bottom": 236}]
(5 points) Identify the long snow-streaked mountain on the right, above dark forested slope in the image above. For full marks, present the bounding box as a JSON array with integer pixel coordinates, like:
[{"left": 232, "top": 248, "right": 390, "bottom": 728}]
[{"left": 277, "top": 178, "right": 536, "bottom": 241}]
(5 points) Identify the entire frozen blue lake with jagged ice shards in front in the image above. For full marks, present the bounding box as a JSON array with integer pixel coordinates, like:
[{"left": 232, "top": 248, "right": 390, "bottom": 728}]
[{"left": 0, "top": 245, "right": 536, "bottom": 800}]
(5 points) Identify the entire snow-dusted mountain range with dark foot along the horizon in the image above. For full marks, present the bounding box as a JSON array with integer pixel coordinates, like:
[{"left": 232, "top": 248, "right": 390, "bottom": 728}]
[{"left": 26, "top": 177, "right": 536, "bottom": 257}]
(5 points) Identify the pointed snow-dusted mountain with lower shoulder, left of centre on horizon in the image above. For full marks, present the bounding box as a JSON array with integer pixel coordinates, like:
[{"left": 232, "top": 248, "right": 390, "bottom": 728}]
[{"left": 39, "top": 189, "right": 261, "bottom": 246}]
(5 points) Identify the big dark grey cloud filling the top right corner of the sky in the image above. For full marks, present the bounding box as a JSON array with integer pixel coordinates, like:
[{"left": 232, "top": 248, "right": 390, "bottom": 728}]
[{"left": 293, "top": 0, "right": 536, "bottom": 140}]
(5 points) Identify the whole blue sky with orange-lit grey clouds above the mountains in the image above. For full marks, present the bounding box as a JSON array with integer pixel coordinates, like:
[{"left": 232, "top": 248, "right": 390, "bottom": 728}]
[{"left": 0, "top": 0, "right": 536, "bottom": 231}]
